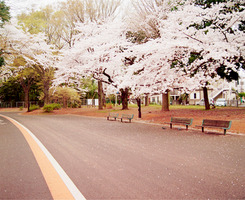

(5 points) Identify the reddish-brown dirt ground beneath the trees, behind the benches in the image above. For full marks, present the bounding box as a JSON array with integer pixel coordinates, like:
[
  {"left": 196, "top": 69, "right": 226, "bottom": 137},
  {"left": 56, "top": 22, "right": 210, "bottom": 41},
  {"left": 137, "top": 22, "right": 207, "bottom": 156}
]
[{"left": 4, "top": 106, "right": 245, "bottom": 134}]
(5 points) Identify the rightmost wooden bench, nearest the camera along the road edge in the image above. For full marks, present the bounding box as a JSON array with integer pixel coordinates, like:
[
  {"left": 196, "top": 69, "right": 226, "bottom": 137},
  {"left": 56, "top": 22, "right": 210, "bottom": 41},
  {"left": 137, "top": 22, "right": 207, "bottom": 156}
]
[{"left": 196, "top": 119, "right": 231, "bottom": 135}]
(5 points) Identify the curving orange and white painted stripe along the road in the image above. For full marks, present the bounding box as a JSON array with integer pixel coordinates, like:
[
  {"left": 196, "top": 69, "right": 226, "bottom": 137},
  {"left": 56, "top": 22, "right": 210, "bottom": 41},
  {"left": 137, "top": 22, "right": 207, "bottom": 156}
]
[{"left": 0, "top": 115, "right": 85, "bottom": 199}]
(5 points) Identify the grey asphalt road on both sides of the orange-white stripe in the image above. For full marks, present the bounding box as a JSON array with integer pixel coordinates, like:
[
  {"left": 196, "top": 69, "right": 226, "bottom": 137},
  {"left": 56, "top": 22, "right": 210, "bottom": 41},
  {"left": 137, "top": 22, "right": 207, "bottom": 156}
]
[{"left": 0, "top": 112, "right": 245, "bottom": 199}]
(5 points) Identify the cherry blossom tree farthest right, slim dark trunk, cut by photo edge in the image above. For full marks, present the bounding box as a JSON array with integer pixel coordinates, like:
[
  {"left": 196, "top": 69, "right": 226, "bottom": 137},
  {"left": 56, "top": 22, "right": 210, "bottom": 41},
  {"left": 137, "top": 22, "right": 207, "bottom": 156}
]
[{"left": 166, "top": 1, "right": 245, "bottom": 109}]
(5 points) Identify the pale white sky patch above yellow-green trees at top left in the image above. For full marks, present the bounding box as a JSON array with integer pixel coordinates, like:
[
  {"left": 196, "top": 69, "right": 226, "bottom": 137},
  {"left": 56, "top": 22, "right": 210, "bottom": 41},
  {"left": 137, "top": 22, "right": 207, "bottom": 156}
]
[{"left": 5, "top": 0, "right": 65, "bottom": 17}]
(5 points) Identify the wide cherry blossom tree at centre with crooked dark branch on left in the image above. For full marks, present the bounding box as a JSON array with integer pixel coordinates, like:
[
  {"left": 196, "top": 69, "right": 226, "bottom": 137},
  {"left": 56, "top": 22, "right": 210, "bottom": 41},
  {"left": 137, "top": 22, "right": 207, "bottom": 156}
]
[{"left": 57, "top": 18, "right": 189, "bottom": 114}]
